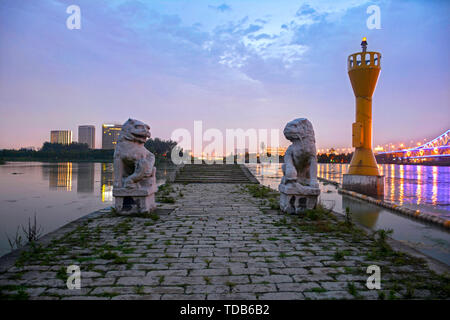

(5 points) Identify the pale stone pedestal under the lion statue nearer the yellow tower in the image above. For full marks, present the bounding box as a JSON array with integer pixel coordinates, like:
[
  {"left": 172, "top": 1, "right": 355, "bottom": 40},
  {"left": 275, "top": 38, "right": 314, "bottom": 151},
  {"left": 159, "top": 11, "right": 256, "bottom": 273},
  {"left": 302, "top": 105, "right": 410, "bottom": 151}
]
[{"left": 278, "top": 183, "right": 320, "bottom": 214}]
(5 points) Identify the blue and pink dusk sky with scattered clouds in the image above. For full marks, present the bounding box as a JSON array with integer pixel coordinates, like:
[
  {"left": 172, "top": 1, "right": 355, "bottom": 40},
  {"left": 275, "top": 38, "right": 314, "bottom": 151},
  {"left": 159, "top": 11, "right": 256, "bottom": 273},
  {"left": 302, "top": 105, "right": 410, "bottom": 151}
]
[{"left": 0, "top": 0, "right": 450, "bottom": 148}]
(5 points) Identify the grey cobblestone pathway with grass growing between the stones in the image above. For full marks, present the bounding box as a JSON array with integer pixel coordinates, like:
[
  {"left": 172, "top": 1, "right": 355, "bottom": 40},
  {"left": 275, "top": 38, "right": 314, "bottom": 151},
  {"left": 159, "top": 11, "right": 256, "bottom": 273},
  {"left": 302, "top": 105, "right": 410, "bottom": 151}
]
[{"left": 0, "top": 184, "right": 448, "bottom": 299}]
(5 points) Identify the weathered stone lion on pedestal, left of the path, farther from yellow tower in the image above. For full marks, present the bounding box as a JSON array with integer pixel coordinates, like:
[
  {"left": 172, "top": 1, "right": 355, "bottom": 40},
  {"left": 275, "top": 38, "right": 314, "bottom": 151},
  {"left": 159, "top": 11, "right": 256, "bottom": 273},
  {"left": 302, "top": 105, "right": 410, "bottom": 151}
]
[{"left": 113, "top": 119, "right": 157, "bottom": 213}]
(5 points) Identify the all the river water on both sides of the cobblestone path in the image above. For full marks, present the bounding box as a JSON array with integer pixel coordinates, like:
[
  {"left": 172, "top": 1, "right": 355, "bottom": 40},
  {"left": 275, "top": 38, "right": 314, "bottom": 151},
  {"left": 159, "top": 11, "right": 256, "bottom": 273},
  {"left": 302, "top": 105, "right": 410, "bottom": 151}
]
[{"left": 0, "top": 162, "right": 450, "bottom": 265}]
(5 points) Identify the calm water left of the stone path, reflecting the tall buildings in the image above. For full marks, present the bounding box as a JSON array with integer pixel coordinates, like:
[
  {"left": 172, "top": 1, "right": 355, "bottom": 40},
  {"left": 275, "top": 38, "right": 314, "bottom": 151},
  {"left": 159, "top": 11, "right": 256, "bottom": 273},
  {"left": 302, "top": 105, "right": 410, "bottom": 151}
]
[{"left": 0, "top": 162, "right": 172, "bottom": 256}]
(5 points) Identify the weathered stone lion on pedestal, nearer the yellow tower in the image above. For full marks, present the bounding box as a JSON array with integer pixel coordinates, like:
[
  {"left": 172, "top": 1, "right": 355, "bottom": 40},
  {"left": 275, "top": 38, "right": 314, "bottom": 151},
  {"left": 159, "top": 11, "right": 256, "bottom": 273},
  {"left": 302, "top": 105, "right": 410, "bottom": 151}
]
[{"left": 278, "top": 118, "right": 320, "bottom": 213}]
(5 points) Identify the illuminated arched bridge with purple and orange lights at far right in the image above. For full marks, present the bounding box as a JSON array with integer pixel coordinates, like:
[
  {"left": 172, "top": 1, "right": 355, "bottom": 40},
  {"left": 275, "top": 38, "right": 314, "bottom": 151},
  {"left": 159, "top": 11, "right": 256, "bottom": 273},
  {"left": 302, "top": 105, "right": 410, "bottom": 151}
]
[{"left": 376, "top": 130, "right": 450, "bottom": 165}]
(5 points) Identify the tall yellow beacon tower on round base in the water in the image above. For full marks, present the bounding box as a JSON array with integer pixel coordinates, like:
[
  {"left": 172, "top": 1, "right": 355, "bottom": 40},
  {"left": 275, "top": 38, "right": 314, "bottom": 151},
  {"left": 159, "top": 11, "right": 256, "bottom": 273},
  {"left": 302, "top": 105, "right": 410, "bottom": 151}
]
[{"left": 342, "top": 38, "right": 384, "bottom": 198}]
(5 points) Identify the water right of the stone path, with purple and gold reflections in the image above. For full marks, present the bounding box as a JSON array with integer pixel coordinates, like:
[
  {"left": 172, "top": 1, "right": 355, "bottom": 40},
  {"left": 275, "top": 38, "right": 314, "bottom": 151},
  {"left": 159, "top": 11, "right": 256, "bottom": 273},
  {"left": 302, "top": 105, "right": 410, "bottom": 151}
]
[{"left": 247, "top": 164, "right": 450, "bottom": 265}]
